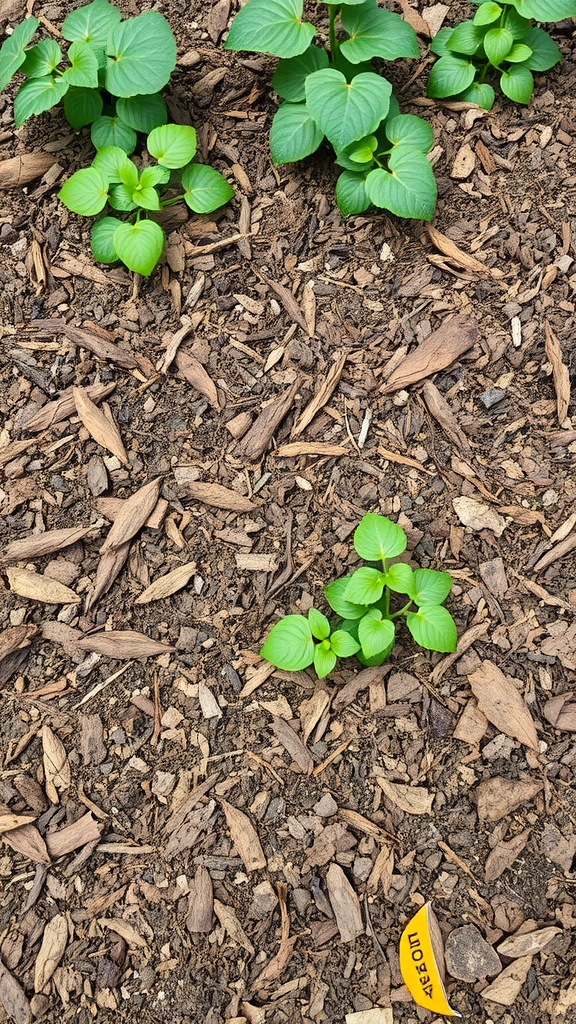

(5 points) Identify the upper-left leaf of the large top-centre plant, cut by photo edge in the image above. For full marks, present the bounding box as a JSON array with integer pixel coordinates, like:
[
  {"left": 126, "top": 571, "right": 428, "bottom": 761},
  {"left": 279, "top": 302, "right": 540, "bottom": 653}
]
[{"left": 224, "top": 0, "right": 315, "bottom": 57}]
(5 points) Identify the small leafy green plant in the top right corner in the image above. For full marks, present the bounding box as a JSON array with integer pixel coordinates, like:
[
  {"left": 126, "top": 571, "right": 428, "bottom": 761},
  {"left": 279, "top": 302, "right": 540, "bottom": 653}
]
[{"left": 427, "top": 0, "right": 565, "bottom": 111}]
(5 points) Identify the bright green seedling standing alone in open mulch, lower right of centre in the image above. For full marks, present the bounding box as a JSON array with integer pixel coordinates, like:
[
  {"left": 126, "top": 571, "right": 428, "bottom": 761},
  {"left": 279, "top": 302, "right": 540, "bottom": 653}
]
[{"left": 260, "top": 512, "right": 457, "bottom": 679}]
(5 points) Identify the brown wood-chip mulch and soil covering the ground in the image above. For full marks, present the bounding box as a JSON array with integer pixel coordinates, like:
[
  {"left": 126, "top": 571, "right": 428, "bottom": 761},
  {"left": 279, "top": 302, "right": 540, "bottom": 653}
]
[{"left": 0, "top": 6, "right": 576, "bottom": 1024}]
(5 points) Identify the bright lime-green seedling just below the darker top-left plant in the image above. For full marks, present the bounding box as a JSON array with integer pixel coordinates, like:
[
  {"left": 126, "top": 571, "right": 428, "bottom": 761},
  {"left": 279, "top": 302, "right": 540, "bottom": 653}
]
[{"left": 58, "top": 124, "right": 234, "bottom": 276}]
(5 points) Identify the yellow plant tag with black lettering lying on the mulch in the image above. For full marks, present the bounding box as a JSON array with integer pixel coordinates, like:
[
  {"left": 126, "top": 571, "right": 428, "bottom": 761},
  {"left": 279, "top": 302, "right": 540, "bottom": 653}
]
[{"left": 400, "top": 903, "right": 461, "bottom": 1017}]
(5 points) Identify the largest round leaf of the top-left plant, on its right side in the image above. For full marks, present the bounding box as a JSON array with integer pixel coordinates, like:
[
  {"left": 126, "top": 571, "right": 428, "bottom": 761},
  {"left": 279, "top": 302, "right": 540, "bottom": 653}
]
[{"left": 105, "top": 10, "right": 176, "bottom": 96}]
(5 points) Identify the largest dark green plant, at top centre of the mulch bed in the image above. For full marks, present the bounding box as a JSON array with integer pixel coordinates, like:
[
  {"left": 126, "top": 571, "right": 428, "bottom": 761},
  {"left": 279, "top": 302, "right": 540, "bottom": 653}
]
[{"left": 224, "top": 0, "right": 437, "bottom": 220}]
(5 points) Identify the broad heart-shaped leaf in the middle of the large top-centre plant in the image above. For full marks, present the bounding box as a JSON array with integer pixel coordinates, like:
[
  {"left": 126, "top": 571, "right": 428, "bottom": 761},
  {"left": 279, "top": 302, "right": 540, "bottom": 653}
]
[{"left": 305, "top": 68, "right": 392, "bottom": 153}]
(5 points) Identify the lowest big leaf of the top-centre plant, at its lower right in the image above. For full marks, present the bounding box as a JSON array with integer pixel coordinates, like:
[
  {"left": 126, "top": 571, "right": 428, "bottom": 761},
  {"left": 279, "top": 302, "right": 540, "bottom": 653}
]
[{"left": 366, "top": 145, "right": 438, "bottom": 220}]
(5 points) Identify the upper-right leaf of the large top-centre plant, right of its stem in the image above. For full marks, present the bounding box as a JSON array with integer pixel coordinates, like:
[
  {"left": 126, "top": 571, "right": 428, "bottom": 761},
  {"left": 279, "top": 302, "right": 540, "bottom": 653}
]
[{"left": 340, "top": 3, "right": 420, "bottom": 63}]
